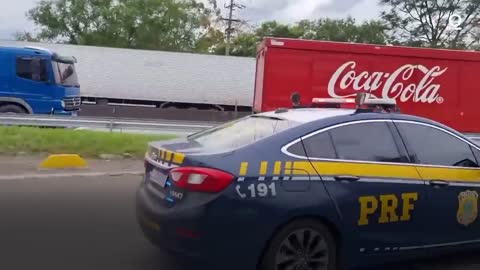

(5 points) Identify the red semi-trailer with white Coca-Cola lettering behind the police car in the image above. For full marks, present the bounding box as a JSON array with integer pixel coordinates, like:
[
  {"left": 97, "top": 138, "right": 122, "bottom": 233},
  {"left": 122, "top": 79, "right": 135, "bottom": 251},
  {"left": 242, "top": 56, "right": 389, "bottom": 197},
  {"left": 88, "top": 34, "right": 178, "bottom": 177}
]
[{"left": 253, "top": 38, "right": 480, "bottom": 133}]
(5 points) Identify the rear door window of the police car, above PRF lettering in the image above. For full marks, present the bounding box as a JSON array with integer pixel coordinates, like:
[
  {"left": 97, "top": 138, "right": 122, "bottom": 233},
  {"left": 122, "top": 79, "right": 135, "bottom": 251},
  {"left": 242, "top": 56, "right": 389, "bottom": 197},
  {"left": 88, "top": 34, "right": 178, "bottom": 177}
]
[{"left": 330, "top": 122, "right": 406, "bottom": 162}]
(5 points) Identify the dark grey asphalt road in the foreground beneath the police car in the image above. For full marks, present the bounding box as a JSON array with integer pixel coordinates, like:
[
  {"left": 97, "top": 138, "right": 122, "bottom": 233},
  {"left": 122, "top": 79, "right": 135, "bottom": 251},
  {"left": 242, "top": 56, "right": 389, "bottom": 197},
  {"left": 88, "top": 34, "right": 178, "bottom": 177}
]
[{"left": 0, "top": 176, "right": 480, "bottom": 270}]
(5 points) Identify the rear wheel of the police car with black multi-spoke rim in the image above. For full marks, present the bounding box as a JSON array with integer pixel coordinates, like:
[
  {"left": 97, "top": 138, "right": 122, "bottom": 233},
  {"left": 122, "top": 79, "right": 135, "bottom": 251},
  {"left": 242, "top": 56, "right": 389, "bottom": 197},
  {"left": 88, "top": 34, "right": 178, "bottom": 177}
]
[{"left": 260, "top": 219, "right": 337, "bottom": 270}]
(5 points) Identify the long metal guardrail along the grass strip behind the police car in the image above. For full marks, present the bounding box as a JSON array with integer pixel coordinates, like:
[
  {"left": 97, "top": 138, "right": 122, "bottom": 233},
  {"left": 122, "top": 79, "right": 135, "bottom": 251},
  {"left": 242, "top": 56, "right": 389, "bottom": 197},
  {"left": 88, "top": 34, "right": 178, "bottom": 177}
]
[{"left": 0, "top": 114, "right": 216, "bottom": 132}]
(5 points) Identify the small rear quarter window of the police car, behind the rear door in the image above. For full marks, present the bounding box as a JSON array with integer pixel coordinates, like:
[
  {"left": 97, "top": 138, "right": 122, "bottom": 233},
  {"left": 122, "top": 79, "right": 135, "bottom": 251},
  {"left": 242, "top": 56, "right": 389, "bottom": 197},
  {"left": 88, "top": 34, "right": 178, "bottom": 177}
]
[{"left": 303, "top": 132, "right": 336, "bottom": 159}]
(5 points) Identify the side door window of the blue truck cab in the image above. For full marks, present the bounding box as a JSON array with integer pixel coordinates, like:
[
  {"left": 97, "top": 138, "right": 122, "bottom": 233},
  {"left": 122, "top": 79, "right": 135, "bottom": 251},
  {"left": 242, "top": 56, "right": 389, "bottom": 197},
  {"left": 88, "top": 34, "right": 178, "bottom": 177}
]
[{"left": 17, "top": 57, "right": 48, "bottom": 82}]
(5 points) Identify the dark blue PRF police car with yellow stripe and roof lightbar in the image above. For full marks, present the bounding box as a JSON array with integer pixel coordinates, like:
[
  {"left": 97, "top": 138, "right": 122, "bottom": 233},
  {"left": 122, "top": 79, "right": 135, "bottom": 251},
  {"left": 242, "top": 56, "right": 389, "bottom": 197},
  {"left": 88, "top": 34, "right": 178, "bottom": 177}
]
[{"left": 136, "top": 93, "right": 480, "bottom": 270}]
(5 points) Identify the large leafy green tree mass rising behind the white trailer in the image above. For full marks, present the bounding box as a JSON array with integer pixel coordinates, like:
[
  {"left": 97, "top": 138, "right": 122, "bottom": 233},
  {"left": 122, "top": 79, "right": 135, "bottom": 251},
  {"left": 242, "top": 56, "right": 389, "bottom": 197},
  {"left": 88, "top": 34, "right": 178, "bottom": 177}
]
[{"left": 23, "top": 0, "right": 216, "bottom": 51}]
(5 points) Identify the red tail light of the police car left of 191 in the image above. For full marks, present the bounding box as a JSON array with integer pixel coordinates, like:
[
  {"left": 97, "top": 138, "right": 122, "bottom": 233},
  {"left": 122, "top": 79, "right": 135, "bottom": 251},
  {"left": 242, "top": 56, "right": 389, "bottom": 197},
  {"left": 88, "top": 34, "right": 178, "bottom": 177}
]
[{"left": 170, "top": 167, "right": 235, "bottom": 193}]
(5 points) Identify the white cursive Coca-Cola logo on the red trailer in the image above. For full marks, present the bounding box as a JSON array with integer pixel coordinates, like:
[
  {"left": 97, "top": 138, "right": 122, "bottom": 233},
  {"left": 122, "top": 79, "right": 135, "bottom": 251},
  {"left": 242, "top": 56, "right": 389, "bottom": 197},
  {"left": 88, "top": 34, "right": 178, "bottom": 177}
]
[{"left": 328, "top": 61, "right": 448, "bottom": 103}]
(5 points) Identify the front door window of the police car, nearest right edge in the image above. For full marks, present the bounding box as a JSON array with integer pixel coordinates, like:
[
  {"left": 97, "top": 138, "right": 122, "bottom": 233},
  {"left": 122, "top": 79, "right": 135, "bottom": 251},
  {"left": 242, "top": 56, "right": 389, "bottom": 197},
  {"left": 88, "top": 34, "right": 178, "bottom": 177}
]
[{"left": 396, "top": 123, "right": 478, "bottom": 167}]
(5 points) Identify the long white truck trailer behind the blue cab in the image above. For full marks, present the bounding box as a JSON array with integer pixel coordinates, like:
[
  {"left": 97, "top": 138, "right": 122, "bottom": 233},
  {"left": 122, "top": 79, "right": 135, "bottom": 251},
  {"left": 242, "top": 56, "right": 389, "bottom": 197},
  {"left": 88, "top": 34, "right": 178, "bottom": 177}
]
[{"left": 0, "top": 40, "right": 255, "bottom": 111}]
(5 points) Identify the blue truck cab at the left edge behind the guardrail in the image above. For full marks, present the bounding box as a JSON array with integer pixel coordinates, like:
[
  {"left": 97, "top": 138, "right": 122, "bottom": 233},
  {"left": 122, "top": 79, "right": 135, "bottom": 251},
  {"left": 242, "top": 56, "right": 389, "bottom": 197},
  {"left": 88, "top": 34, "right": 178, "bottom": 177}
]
[{"left": 0, "top": 47, "right": 81, "bottom": 116}]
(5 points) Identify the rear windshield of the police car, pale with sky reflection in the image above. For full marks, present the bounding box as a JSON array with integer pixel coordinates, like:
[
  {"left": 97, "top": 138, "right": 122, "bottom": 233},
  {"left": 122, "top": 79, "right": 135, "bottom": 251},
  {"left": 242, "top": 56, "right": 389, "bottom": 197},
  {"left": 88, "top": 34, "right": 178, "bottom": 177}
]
[{"left": 189, "top": 115, "right": 300, "bottom": 149}]
